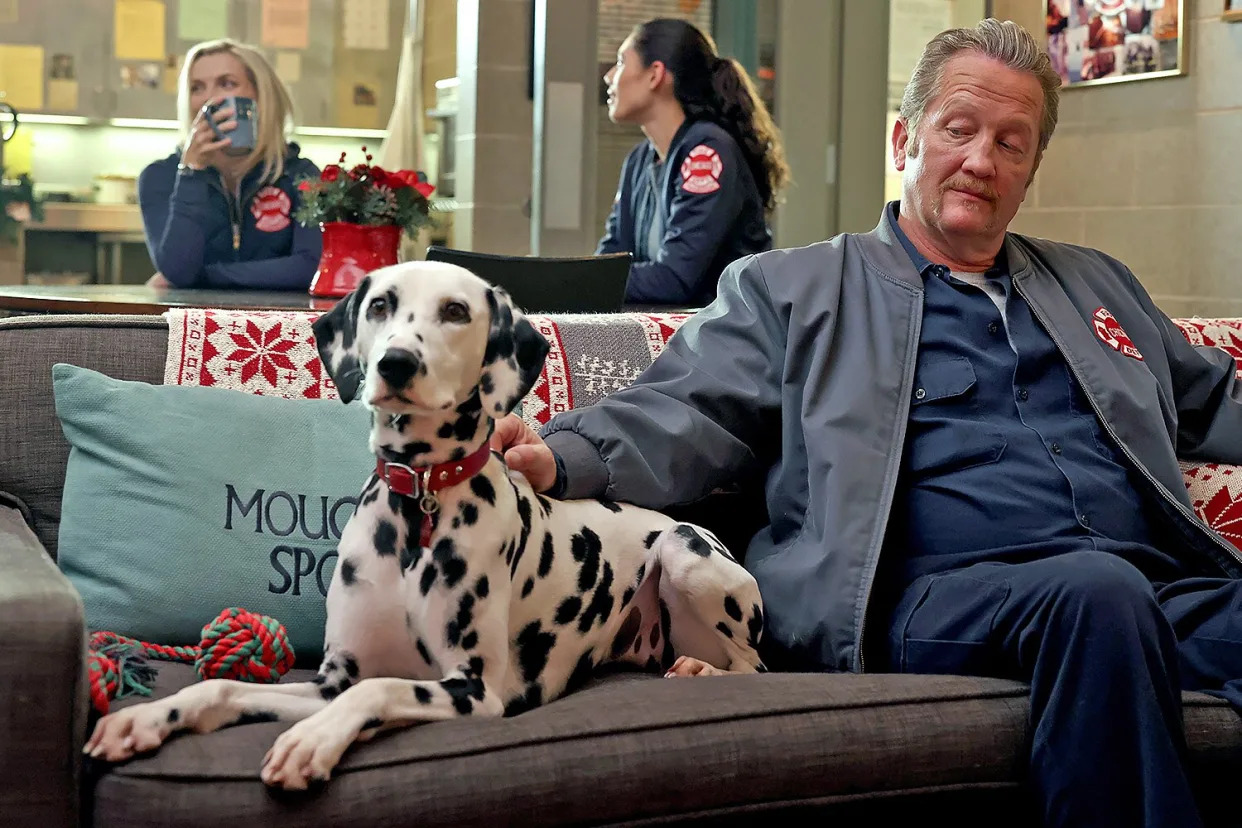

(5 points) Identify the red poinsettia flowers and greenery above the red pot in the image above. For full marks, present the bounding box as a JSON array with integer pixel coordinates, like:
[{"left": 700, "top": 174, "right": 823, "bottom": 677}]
[{"left": 294, "top": 146, "right": 436, "bottom": 235}]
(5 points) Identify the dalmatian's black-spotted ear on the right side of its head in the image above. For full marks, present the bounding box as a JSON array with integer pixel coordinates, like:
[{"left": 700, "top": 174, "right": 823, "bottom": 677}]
[{"left": 478, "top": 288, "right": 550, "bottom": 420}]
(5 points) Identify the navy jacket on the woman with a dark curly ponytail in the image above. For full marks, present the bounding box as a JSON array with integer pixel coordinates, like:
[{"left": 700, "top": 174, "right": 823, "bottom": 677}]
[{"left": 595, "top": 120, "right": 773, "bottom": 307}]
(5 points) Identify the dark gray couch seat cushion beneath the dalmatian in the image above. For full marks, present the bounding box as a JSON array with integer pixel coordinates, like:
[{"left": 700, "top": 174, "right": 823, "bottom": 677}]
[{"left": 94, "top": 664, "right": 1242, "bottom": 828}]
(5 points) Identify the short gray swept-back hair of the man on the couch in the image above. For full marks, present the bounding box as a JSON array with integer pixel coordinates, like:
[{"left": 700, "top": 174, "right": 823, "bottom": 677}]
[{"left": 900, "top": 17, "right": 1061, "bottom": 153}]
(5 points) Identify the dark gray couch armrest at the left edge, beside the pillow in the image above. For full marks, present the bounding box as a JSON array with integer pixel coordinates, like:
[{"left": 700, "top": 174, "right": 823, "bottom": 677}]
[{"left": 0, "top": 505, "right": 88, "bottom": 828}]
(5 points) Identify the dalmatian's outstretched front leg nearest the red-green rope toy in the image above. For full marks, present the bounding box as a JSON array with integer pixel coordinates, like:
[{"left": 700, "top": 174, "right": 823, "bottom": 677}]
[{"left": 82, "top": 655, "right": 358, "bottom": 762}]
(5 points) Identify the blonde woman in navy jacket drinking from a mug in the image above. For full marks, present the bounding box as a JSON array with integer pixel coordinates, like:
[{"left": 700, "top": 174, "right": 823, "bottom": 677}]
[{"left": 138, "top": 40, "right": 323, "bottom": 290}]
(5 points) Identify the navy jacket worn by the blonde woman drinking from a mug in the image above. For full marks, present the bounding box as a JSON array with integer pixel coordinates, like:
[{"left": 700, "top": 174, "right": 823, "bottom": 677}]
[{"left": 138, "top": 144, "right": 323, "bottom": 290}]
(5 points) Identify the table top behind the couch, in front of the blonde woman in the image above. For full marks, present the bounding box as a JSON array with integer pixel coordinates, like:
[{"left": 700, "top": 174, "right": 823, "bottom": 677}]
[{"left": 0, "top": 284, "right": 338, "bottom": 314}]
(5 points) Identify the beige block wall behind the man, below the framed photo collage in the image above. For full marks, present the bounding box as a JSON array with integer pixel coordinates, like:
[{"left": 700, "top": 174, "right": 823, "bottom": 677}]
[{"left": 994, "top": 0, "right": 1242, "bottom": 317}]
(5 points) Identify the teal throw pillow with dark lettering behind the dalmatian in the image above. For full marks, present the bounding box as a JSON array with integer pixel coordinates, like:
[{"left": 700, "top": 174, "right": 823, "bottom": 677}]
[{"left": 52, "top": 364, "right": 375, "bottom": 664}]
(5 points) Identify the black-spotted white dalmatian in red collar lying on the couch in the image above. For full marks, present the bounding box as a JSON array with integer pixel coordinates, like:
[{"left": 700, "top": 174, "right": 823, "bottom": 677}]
[{"left": 84, "top": 262, "right": 764, "bottom": 790}]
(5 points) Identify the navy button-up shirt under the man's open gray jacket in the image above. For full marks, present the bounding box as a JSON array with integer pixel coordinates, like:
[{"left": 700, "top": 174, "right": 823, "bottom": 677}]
[{"left": 887, "top": 204, "right": 1177, "bottom": 582}]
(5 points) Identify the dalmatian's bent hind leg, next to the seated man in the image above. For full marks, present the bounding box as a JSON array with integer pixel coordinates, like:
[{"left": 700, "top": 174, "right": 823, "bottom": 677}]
[{"left": 652, "top": 523, "right": 764, "bottom": 675}]
